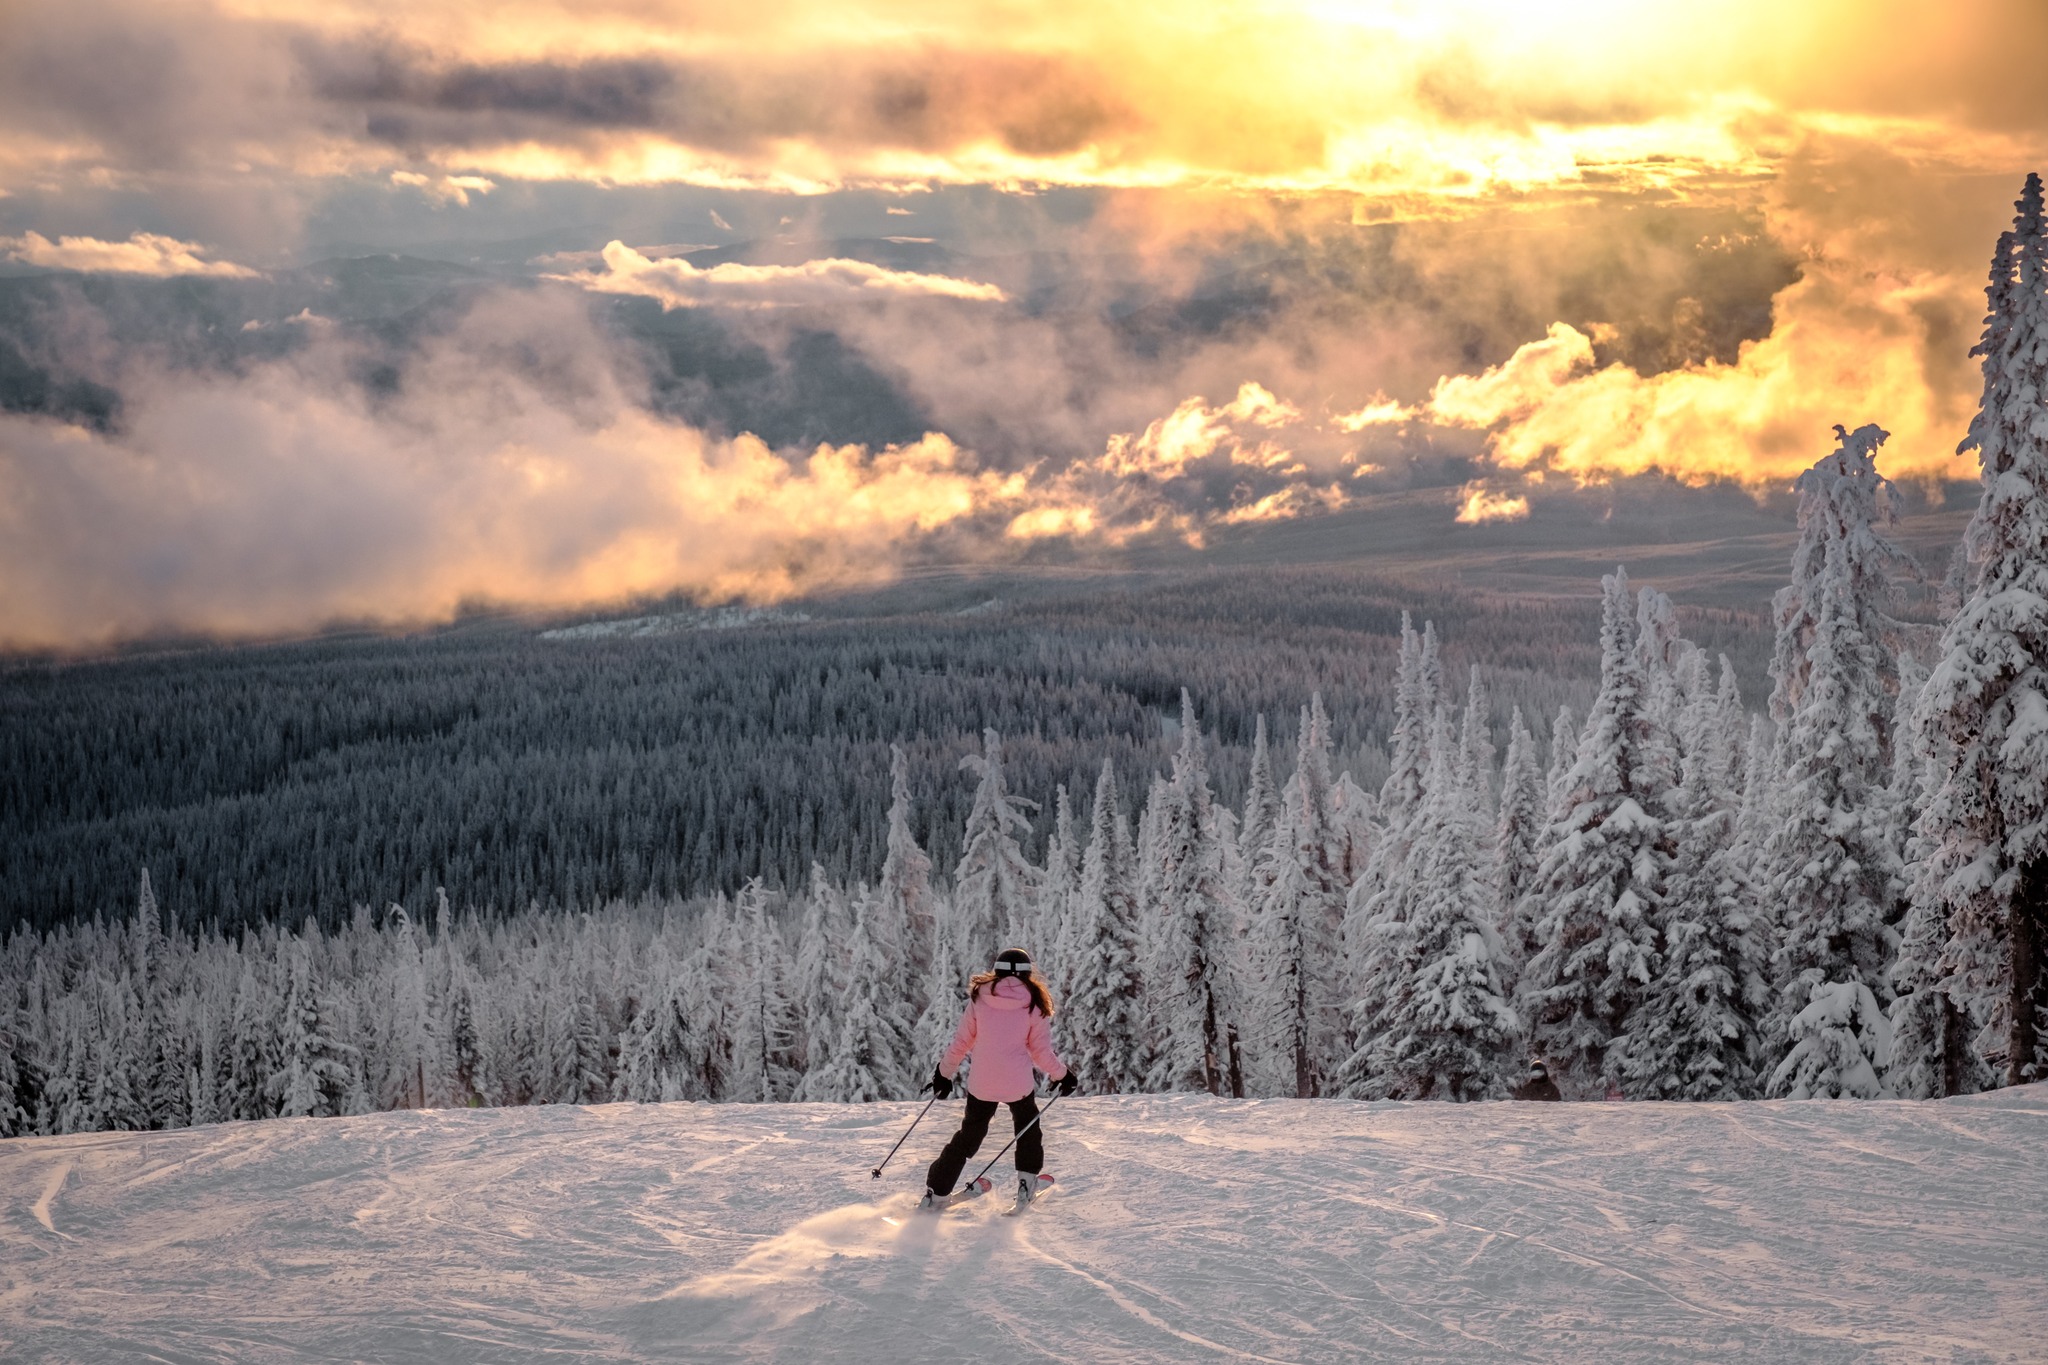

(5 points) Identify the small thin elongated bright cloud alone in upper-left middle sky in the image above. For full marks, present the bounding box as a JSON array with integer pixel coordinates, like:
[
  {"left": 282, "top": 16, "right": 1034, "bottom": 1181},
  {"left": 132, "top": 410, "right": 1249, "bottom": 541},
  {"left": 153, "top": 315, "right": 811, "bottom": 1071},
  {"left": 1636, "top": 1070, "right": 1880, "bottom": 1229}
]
[{"left": 551, "top": 241, "right": 1006, "bottom": 309}]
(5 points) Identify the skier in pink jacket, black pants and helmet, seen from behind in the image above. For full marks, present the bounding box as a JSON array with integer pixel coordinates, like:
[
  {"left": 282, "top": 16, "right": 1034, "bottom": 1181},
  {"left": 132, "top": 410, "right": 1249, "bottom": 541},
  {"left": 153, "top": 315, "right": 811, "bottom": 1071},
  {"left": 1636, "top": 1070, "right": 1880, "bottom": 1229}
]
[{"left": 918, "top": 948, "right": 1079, "bottom": 1209}]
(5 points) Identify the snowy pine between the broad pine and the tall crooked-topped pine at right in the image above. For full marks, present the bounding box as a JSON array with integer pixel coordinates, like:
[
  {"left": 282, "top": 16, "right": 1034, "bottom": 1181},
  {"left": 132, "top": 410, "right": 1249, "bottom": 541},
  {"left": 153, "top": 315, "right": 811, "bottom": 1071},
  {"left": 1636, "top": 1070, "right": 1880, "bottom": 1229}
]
[{"left": 1614, "top": 667, "right": 1769, "bottom": 1099}]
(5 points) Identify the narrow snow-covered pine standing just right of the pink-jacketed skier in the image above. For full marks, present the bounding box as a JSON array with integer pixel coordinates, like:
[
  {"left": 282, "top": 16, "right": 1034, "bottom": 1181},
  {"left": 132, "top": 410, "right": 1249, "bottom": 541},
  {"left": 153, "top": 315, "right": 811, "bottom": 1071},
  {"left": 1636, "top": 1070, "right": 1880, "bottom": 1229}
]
[{"left": 1055, "top": 759, "right": 1145, "bottom": 1095}]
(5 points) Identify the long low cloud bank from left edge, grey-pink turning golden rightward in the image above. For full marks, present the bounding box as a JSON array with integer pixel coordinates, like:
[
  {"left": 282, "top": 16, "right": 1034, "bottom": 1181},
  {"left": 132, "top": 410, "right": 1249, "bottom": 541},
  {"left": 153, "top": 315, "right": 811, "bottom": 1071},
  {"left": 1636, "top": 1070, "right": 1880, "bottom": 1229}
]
[{"left": 0, "top": 289, "right": 1376, "bottom": 649}]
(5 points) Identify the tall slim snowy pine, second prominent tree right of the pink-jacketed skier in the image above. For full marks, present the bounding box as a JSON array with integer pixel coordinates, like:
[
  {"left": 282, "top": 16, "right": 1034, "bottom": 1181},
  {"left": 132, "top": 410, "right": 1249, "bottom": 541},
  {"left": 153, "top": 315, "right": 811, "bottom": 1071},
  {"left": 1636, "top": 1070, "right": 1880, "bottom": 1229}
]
[{"left": 1145, "top": 690, "right": 1231, "bottom": 1095}]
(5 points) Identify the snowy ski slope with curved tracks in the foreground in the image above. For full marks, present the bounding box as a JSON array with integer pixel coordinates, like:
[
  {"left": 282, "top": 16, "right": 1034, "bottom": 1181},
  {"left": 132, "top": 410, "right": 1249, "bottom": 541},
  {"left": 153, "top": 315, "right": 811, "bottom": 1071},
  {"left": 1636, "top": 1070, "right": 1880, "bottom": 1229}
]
[{"left": 0, "top": 1087, "right": 2048, "bottom": 1365}]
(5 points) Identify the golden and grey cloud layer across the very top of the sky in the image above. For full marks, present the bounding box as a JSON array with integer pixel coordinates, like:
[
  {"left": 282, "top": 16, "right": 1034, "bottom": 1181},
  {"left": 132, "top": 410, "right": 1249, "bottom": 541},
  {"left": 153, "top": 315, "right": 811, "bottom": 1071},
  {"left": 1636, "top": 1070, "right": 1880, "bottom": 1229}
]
[{"left": 0, "top": 0, "right": 2048, "bottom": 206}]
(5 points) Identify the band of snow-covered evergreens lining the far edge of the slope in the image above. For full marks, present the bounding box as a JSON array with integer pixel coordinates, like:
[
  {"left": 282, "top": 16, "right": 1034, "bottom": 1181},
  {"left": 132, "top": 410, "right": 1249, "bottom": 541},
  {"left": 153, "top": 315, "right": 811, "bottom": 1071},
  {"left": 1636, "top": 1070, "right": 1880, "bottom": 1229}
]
[{"left": 12, "top": 178, "right": 2048, "bottom": 1134}]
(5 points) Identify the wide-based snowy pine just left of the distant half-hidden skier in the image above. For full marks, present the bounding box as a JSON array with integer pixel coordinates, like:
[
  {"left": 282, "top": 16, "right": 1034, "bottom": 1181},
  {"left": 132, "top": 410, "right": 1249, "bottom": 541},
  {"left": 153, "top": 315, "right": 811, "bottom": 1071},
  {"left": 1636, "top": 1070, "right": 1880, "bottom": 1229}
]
[{"left": 1346, "top": 708, "right": 1522, "bottom": 1101}]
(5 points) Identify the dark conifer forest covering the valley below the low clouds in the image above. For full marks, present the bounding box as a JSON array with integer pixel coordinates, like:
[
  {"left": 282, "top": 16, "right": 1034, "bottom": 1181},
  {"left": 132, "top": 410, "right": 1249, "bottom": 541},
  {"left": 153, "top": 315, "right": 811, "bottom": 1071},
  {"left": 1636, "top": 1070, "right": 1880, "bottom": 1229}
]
[{"left": 0, "top": 569, "right": 1712, "bottom": 941}]
